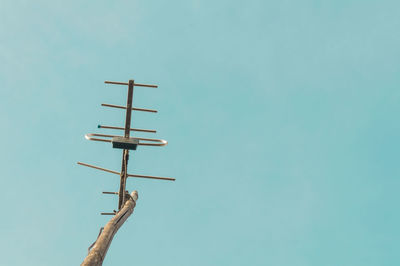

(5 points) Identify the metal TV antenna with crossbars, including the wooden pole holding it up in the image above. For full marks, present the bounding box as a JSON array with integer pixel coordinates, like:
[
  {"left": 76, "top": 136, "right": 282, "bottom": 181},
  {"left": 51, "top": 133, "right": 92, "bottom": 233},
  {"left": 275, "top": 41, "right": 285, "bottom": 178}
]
[{"left": 78, "top": 80, "right": 175, "bottom": 265}]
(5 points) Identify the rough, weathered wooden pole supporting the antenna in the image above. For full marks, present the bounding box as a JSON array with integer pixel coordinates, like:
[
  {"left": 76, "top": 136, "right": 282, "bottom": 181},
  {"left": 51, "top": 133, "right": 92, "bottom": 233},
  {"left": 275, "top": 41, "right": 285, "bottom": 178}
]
[{"left": 81, "top": 190, "right": 138, "bottom": 266}]
